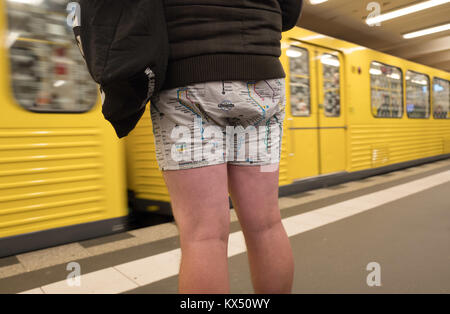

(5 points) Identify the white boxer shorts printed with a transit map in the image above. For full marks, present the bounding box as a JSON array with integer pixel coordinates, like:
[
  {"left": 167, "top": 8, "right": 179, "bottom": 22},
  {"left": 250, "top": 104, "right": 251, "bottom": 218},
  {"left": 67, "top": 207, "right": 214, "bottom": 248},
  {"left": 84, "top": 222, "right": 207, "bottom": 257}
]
[{"left": 150, "top": 78, "right": 286, "bottom": 170}]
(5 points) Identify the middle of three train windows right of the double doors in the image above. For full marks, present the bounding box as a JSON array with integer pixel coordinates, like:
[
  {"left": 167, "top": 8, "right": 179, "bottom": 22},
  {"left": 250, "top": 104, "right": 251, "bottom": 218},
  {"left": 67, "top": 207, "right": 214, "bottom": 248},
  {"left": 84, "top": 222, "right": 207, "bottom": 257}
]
[{"left": 405, "top": 71, "right": 430, "bottom": 119}]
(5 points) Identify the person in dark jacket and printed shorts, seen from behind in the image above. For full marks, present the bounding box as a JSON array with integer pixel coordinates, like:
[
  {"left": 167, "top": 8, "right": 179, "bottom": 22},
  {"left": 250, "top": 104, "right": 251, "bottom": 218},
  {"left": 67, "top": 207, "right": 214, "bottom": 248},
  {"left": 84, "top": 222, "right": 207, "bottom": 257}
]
[{"left": 150, "top": 0, "right": 302, "bottom": 293}]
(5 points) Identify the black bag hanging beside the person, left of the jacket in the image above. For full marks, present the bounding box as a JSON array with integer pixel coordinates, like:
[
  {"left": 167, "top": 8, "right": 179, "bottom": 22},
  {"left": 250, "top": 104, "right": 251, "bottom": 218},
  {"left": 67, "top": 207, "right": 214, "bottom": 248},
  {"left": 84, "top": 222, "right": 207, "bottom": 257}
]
[{"left": 73, "top": 0, "right": 169, "bottom": 138}]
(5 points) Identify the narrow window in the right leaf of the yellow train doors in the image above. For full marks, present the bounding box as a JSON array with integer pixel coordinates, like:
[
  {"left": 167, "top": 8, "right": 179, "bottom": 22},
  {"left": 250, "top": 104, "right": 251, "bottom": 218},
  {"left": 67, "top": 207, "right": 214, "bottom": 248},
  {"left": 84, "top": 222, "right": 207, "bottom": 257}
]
[{"left": 320, "top": 54, "right": 341, "bottom": 117}]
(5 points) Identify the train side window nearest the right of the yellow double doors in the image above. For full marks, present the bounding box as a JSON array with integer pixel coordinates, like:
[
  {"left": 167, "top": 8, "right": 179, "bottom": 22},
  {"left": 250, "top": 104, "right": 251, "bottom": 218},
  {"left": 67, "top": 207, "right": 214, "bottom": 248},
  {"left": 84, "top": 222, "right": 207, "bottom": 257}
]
[{"left": 370, "top": 62, "right": 403, "bottom": 118}]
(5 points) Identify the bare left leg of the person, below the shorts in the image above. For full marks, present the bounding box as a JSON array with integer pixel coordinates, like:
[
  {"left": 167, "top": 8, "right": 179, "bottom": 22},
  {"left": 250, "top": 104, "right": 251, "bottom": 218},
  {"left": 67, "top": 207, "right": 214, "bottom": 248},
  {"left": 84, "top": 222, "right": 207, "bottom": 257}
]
[{"left": 163, "top": 164, "right": 230, "bottom": 293}]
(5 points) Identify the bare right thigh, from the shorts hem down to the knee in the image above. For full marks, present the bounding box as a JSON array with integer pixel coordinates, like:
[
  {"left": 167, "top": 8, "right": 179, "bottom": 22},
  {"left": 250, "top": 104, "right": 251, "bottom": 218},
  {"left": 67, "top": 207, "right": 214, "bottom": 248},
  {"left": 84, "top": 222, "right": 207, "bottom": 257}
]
[{"left": 228, "top": 164, "right": 281, "bottom": 233}]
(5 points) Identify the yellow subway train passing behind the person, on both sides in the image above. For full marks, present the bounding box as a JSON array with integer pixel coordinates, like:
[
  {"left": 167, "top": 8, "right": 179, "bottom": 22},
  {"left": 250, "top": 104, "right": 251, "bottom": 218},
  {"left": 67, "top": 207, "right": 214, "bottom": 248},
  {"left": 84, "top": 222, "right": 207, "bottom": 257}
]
[{"left": 0, "top": 0, "right": 450, "bottom": 257}]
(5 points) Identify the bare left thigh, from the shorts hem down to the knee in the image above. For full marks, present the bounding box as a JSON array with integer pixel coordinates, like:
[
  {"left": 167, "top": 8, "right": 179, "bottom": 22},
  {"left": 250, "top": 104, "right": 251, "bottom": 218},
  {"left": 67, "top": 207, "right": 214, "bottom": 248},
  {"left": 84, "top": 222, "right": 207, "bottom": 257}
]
[{"left": 163, "top": 164, "right": 230, "bottom": 242}]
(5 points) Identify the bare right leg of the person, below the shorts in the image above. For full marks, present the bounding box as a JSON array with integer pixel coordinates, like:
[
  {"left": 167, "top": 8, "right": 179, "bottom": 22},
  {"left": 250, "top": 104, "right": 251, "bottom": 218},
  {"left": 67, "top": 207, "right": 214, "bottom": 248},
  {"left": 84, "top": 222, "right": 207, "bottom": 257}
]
[{"left": 228, "top": 165, "right": 294, "bottom": 293}]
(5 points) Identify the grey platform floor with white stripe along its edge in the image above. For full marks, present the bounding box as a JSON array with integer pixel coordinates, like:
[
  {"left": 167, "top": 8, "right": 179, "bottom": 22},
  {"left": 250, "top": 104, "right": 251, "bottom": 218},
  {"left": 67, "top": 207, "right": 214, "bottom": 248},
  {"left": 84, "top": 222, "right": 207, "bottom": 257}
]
[{"left": 0, "top": 160, "right": 450, "bottom": 294}]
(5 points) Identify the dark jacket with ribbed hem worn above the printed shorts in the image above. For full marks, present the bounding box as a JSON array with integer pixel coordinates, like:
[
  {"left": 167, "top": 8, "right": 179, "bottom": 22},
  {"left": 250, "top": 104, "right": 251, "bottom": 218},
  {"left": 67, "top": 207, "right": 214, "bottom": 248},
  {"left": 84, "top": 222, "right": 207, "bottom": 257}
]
[{"left": 163, "top": 0, "right": 302, "bottom": 89}]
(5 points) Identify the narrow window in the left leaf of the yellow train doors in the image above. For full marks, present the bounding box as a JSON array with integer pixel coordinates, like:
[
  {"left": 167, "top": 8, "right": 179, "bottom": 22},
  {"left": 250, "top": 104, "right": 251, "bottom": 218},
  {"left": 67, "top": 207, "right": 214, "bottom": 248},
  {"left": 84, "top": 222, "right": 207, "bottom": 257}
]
[{"left": 287, "top": 46, "right": 311, "bottom": 117}]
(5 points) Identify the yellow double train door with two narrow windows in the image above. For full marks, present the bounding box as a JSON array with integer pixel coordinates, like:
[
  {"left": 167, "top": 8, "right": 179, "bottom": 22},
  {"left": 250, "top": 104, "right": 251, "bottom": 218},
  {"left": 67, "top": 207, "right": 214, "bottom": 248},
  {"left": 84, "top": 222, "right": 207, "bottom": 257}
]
[{"left": 285, "top": 42, "right": 346, "bottom": 180}]
